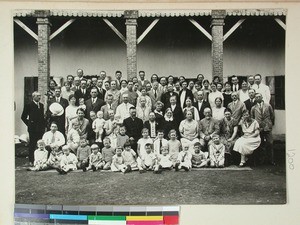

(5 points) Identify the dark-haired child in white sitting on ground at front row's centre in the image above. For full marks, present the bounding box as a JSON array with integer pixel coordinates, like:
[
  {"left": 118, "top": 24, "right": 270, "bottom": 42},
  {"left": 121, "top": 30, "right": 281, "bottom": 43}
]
[{"left": 137, "top": 143, "right": 156, "bottom": 173}]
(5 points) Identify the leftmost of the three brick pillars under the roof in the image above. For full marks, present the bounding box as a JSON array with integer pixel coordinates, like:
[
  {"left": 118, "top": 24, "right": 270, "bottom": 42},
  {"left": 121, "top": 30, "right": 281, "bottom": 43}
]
[{"left": 35, "top": 10, "right": 51, "bottom": 105}]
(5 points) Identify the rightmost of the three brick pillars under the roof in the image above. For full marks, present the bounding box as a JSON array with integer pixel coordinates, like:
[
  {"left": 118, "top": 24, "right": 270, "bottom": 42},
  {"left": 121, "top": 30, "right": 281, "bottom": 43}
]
[{"left": 211, "top": 10, "right": 226, "bottom": 81}]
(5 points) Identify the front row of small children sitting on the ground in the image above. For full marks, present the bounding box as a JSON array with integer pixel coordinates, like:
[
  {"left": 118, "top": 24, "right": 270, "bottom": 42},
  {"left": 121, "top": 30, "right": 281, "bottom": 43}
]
[{"left": 28, "top": 131, "right": 225, "bottom": 174}]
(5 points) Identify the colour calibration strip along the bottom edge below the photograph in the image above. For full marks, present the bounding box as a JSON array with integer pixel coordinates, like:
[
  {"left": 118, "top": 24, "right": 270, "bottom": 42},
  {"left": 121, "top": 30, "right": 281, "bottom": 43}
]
[{"left": 14, "top": 204, "right": 179, "bottom": 225}]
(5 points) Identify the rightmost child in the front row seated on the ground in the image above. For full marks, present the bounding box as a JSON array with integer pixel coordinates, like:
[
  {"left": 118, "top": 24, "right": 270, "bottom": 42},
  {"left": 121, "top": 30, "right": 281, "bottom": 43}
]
[{"left": 209, "top": 134, "right": 225, "bottom": 167}]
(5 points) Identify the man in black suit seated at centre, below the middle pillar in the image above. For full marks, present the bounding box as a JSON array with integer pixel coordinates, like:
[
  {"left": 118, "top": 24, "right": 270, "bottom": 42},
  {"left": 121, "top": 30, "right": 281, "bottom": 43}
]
[{"left": 123, "top": 107, "right": 143, "bottom": 152}]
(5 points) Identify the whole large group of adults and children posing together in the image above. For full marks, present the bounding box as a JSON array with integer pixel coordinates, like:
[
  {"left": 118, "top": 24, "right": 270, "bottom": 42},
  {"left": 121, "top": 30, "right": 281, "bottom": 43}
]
[{"left": 21, "top": 69, "right": 275, "bottom": 174}]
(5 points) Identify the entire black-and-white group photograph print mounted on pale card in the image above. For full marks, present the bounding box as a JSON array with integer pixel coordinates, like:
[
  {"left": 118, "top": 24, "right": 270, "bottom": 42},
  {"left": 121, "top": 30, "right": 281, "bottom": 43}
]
[{"left": 12, "top": 8, "right": 286, "bottom": 205}]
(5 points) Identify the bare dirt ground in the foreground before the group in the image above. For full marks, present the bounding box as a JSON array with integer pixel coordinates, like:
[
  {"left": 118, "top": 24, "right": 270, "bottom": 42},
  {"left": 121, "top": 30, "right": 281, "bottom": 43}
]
[{"left": 15, "top": 143, "right": 286, "bottom": 205}]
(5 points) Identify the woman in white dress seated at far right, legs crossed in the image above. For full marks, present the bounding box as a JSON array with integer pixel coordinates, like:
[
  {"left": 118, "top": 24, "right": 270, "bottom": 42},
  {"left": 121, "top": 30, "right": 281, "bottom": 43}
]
[{"left": 233, "top": 111, "right": 261, "bottom": 167}]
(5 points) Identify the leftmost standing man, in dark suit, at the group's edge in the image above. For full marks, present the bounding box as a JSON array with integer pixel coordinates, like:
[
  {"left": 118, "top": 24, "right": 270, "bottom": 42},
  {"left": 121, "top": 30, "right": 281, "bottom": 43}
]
[{"left": 21, "top": 91, "right": 46, "bottom": 166}]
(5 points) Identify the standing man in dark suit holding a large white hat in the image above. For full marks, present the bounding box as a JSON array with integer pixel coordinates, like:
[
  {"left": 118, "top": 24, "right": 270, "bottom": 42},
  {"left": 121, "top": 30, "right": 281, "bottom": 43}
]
[{"left": 47, "top": 87, "right": 69, "bottom": 135}]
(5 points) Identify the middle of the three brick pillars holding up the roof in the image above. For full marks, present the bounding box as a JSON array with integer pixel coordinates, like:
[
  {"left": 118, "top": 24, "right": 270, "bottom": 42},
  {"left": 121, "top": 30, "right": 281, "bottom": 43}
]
[{"left": 124, "top": 10, "right": 138, "bottom": 79}]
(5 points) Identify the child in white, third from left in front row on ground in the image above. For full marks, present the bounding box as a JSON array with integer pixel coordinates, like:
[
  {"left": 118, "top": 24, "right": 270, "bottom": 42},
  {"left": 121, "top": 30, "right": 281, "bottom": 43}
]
[{"left": 56, "top": 145, "right": 78, "bottom": 174}]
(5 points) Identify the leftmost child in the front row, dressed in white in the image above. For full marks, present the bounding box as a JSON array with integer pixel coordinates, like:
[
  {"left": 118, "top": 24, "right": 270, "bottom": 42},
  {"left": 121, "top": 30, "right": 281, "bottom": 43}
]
[{"left": 28, "top": 139, "right": 48, "bottom": 171}]
